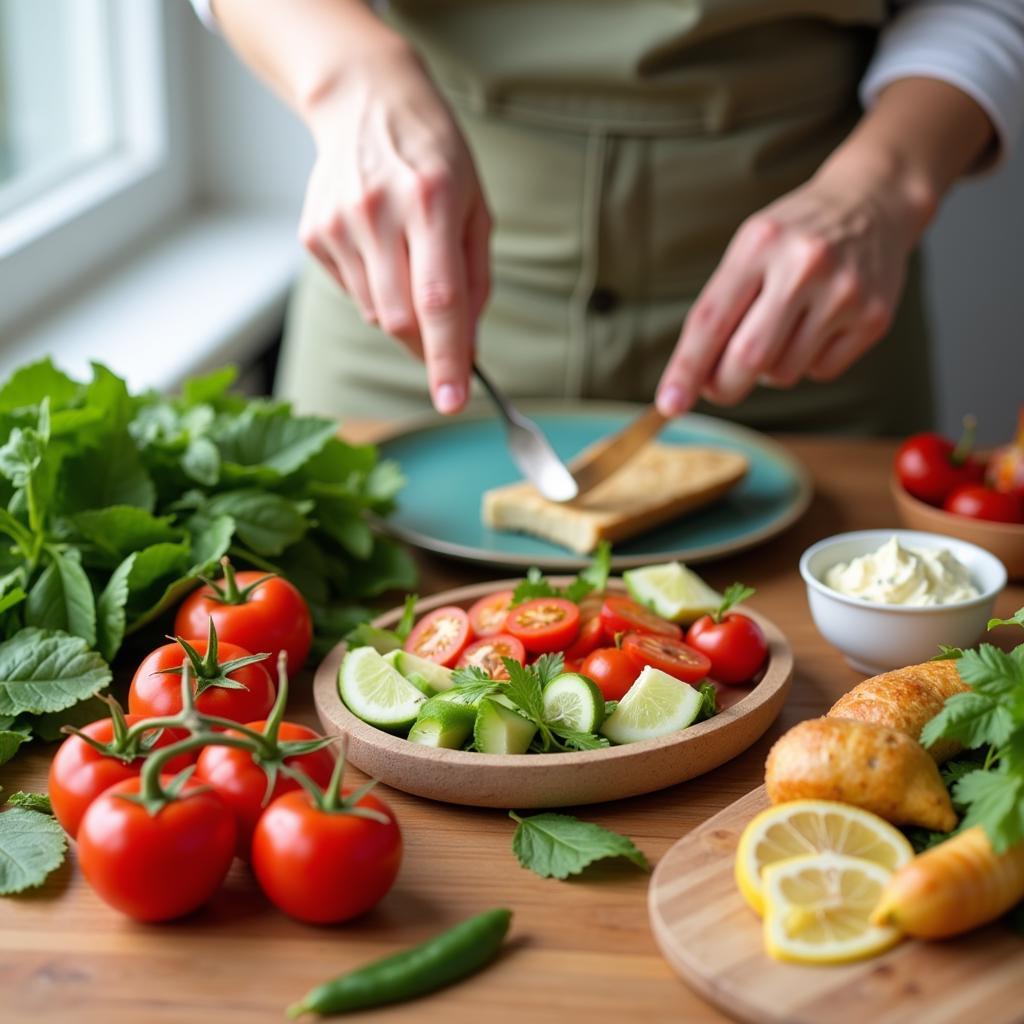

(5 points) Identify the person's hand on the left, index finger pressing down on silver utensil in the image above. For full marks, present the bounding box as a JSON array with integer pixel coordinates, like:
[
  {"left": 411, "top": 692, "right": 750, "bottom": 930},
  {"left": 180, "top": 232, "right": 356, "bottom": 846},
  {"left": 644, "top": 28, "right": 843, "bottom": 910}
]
[{"left": 299, "top": 45, "right": 490, "bottom": 414}]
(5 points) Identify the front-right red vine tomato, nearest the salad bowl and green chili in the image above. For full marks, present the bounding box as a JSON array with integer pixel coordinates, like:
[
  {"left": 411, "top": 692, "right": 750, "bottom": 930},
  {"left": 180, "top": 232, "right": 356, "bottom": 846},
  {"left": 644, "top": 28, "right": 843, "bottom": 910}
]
[{"left": 252, "top": 790, "right": 401, "bottom": 925}]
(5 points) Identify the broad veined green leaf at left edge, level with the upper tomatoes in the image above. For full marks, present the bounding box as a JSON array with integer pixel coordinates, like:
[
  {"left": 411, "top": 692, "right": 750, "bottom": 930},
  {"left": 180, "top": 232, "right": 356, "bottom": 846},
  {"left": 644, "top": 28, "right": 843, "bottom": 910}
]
[{"left": 0, "top": 628, "right": 111, "bottom": 715}]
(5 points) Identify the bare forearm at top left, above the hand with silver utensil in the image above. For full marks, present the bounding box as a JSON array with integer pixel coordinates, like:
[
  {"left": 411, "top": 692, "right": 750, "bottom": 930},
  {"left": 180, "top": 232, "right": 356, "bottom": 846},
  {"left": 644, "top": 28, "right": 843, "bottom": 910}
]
[{"left": 214, "top": 0, "right": 409, "bottom": 123}]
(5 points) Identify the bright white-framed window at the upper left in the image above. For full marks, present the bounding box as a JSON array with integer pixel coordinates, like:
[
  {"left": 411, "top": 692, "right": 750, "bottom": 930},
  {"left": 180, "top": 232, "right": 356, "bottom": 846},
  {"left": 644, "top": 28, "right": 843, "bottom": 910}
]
[{"left": 0, "top": 0, "right": 187, "bottom": 335}]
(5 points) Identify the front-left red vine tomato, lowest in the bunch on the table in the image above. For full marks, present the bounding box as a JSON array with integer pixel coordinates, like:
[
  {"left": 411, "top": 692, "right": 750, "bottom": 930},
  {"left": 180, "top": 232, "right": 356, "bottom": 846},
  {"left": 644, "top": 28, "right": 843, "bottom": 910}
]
[{"left": 78, "top": 775, "right": 234, "bottom": 921}]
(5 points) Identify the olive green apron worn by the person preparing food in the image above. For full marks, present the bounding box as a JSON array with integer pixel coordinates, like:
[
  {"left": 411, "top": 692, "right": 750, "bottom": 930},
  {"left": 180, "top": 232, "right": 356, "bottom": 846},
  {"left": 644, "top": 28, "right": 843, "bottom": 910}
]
[{"left": 279, "top": 0, "right": 931, "bottom": 433}]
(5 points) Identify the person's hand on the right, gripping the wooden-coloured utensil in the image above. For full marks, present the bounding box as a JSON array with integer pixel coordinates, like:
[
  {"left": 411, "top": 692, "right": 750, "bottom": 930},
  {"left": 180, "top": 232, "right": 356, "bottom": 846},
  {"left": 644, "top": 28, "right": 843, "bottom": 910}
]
[{"left": 657, "top": 153, "right": 931, "bottom": 416}]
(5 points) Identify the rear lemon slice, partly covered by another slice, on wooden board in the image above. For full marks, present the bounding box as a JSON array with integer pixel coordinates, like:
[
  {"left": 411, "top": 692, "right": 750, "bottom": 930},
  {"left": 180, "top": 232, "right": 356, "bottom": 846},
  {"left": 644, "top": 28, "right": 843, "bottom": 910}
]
[{"left": 736, "top": 800, "right": 913, "bottom": 913}]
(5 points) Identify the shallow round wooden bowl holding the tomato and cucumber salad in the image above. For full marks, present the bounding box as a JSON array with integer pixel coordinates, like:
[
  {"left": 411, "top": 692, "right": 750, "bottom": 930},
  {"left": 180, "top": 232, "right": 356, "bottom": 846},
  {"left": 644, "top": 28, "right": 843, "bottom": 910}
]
[{"left": 313, "top": 577, "right": 793, "bottom": 808}]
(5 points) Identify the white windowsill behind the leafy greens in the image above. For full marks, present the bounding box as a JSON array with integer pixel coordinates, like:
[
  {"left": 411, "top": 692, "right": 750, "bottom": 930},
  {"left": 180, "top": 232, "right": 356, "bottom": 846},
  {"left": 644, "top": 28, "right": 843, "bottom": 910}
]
[{"left": 0, "top": 210, "right": 300, "bottom": 390}]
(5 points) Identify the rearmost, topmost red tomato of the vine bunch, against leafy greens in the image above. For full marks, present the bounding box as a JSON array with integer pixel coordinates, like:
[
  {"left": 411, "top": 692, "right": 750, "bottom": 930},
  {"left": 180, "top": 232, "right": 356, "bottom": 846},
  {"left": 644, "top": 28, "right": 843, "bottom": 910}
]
[{"left": 174, "top": 570, "right": 313, "bottom": 682}]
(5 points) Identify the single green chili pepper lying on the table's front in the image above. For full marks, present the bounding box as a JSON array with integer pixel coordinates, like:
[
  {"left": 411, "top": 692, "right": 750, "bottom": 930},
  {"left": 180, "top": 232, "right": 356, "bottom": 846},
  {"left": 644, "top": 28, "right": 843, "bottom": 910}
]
[{"left": 288, "top": 909, "right": 512, "bottom": 1017}]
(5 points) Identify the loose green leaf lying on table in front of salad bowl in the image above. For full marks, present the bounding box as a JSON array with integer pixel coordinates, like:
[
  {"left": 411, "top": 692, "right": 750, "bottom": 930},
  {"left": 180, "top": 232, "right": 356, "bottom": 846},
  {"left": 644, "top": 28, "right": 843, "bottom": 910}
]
[{"left": 509, "top": 811, "right": 649, "bottom": 879}]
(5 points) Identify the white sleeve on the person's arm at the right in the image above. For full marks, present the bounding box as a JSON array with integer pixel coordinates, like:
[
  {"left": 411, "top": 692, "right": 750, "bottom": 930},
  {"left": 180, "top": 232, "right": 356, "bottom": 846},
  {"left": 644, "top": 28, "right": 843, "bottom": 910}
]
[{"left": 860, "top": 0, "right": 1024, "bottom": 160}]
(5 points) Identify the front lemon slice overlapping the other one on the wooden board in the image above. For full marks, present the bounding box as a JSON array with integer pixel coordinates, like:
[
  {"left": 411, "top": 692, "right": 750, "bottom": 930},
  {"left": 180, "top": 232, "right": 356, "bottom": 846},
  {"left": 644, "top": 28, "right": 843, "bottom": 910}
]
[{"left": 764, "top": 853, "right": 900, "bottom": 964}]
